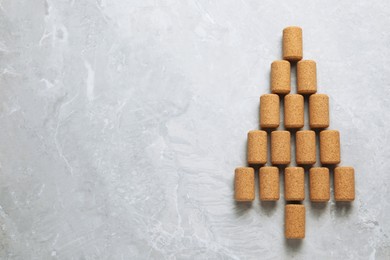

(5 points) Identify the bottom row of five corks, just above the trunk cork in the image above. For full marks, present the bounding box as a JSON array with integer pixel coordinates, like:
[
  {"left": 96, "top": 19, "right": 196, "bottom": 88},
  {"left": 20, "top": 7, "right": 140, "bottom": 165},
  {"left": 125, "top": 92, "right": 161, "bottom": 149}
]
[{"left": 234, "top": 166, "right": 355, "bottom": 202}]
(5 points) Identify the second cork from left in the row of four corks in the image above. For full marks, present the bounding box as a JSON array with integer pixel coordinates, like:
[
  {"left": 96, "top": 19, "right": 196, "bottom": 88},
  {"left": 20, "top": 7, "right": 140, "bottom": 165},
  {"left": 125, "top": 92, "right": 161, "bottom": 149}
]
[{"left": 271, "top": 131, "right": 291, "bottom": 165}]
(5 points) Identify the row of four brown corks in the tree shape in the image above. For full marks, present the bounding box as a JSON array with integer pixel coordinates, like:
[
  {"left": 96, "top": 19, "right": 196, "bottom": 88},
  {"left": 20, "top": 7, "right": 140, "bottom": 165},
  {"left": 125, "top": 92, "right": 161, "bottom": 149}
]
[{"left": 247, "top": 130, "right": 341, "bottom": 165}]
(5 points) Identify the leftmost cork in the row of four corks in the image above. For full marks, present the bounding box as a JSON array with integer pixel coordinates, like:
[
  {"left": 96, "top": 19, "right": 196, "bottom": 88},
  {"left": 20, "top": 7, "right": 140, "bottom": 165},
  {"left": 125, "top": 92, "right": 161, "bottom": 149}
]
[{"left": 247, "top": 130, "right": 267, "bottom": 164}]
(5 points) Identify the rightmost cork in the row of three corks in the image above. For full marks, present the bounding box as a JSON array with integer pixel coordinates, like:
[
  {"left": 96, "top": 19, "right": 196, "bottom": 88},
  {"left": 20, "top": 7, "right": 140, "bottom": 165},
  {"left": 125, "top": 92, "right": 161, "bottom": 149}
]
[{"left": 309, "top": 94, "right": 329, "bottom": 128}]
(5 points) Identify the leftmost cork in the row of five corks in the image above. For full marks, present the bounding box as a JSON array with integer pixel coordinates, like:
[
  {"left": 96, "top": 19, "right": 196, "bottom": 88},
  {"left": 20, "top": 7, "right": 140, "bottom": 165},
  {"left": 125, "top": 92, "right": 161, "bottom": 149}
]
[{"left": 234, "top": 167, "right": 255, "bottom": 201}]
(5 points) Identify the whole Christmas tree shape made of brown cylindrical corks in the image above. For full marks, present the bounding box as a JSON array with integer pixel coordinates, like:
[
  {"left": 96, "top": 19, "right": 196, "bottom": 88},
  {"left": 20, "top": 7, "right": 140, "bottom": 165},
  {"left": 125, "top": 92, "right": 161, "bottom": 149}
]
[{"left": 234, "top": 26, "right": 355, "bottom": 239}]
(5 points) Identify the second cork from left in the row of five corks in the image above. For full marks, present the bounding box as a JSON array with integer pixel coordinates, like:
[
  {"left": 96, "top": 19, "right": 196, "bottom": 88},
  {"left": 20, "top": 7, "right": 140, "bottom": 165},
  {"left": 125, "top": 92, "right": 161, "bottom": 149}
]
[{"left": 259, "top": 167, "right": 280, "bottom": 200}]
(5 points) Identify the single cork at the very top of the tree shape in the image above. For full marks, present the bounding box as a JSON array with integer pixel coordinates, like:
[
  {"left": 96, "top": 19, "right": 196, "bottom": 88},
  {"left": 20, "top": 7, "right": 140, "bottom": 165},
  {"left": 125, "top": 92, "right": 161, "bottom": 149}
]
[{"left": 283, "top": 26, "right": 303, "bottom": 61}]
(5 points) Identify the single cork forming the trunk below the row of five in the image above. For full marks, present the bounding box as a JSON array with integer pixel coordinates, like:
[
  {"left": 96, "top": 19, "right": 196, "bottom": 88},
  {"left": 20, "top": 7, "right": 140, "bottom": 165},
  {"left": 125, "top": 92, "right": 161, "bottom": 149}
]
[{"left": 284, "top": 204, "right": 306, "bottom": 239}]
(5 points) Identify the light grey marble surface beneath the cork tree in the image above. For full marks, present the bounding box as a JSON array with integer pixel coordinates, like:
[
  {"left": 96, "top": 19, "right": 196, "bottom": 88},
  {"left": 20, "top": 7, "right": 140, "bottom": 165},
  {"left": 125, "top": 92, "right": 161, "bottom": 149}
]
[{"left": 0, "top": 0, "right": 390, "bottom": 259}]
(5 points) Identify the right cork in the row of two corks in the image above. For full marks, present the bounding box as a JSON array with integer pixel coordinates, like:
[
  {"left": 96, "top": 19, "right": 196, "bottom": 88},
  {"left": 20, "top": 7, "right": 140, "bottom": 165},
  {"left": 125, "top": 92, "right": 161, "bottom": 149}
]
[{"left": 297, "top": 60, "right": 317, "bottom": 94}]
